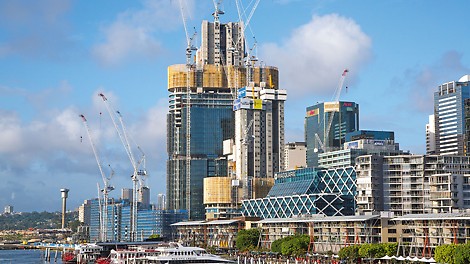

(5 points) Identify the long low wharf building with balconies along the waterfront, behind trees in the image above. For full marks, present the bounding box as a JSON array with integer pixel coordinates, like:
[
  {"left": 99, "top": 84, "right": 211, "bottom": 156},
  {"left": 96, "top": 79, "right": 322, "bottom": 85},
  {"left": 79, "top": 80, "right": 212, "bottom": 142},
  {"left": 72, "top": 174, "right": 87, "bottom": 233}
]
[{"left": 172, "top": 211, "right": 470, "bottom": 258}]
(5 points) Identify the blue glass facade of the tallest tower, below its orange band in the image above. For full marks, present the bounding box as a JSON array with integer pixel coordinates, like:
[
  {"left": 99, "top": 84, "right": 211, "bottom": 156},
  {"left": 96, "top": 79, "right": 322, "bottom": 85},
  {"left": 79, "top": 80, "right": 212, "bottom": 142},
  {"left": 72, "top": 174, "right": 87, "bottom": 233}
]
[{"left": 167, "top": 89, "right": 235, "bottom": 220}]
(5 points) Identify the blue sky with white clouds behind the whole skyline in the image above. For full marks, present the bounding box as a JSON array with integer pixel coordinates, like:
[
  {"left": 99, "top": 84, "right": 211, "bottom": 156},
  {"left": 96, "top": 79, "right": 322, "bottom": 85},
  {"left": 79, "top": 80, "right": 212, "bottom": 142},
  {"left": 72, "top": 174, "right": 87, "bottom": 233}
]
[{"left": 0, "top": 0, "right": 470, "bottom": 211}]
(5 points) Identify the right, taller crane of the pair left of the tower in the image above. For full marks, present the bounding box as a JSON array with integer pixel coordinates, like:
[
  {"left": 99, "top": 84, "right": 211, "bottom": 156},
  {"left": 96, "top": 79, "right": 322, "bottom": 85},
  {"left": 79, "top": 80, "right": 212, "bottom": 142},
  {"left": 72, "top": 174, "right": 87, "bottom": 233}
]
[{"left": 98, "top": 93, "right": 147, "bottom": 241}]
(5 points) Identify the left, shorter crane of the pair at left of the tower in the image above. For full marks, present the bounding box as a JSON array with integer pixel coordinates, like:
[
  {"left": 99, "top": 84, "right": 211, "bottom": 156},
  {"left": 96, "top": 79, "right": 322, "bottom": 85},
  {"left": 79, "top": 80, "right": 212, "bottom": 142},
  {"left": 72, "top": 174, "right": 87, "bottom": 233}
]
[{"left": 80, "top": 115, "right": 114, "bottom": 241}]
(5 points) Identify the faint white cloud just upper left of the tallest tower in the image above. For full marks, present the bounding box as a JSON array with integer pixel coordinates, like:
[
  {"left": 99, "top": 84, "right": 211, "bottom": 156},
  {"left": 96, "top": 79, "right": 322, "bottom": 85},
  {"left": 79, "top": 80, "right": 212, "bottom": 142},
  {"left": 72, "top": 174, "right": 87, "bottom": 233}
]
[{"left": 93, "top": 0, "right": 194, "bottom": 65}]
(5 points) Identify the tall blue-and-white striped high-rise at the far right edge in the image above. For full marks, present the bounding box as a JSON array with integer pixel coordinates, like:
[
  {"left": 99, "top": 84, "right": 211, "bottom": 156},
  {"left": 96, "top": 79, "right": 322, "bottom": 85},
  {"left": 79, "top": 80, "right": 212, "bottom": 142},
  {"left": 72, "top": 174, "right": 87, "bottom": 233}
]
[{"left": 434, "top": 75, "right": 470, "bottom": 155}]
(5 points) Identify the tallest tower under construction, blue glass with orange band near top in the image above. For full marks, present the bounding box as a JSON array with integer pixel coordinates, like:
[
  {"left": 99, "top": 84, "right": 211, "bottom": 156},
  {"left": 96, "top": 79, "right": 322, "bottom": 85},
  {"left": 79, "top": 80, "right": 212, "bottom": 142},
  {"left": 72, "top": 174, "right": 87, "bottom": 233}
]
[{"left": 166, "top": 10, "right": 284, "bottom": 220}]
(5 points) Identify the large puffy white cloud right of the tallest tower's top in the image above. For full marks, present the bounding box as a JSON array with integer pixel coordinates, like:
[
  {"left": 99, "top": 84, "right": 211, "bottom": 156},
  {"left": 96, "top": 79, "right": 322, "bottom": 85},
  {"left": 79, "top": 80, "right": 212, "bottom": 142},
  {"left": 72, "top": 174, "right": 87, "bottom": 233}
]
[{"left": 260, "top": 14, "right": 372, "bottom": 100}]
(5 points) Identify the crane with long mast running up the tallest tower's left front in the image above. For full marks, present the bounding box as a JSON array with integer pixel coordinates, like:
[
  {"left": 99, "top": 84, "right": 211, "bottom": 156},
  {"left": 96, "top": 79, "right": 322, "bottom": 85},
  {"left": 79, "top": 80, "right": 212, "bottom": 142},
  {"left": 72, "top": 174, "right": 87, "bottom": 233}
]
[{"left": 179, "top": 0, "right": 197, "bottom": 218}]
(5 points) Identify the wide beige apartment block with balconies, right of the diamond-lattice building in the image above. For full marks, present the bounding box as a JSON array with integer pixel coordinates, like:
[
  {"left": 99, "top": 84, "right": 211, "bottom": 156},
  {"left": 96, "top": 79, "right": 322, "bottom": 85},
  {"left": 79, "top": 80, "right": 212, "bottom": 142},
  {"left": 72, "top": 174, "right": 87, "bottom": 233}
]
[{"left": 356, "top": 155, "right": 470, "bottom": 216}]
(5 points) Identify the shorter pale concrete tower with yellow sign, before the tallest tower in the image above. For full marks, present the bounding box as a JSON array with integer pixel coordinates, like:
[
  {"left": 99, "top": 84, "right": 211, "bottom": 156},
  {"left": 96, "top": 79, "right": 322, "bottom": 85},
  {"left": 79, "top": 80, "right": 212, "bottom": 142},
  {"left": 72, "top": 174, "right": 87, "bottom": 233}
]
[{"left": 233, "top": 82, "right": 287, "bottom": 199}]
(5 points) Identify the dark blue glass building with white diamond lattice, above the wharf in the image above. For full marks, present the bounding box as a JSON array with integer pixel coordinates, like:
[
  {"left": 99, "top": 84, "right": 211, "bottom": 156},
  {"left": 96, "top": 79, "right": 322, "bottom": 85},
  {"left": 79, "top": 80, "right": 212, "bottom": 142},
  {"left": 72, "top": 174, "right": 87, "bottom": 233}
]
[{"left": 242, "top": 167, "right": 356, "bottom": 219}]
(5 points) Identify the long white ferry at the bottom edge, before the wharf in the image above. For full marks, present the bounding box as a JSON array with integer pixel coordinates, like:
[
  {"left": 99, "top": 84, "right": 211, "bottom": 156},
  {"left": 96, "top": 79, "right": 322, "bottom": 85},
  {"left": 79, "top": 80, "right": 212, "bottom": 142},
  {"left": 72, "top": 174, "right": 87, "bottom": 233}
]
[{"left": 110, "top": 243, "right": 235, "bottom": 264}]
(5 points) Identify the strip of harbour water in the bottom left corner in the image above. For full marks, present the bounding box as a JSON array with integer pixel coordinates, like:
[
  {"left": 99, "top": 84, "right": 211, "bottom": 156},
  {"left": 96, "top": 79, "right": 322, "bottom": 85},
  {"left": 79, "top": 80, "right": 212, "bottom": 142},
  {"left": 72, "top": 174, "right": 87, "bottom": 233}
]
[{"left": 0, "top": 249, "right": 62, "bottom": 264}]
